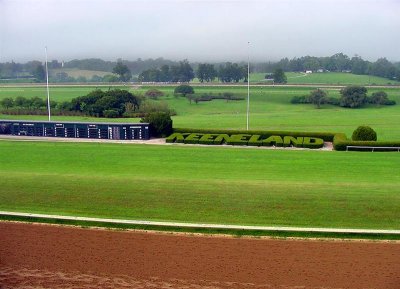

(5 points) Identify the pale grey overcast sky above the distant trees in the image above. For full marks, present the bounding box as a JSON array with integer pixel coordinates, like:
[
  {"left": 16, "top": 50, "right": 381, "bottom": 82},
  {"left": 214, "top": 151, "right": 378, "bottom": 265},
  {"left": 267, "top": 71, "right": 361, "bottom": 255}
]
[{"left": 0, "top": 0, "right": 400, "bottom": 62}]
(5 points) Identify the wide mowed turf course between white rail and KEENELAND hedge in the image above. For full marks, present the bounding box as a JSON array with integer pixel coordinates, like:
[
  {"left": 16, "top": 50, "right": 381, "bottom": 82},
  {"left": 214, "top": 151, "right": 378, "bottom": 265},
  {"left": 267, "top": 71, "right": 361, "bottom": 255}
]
[{"left": 0, "top": 140, "right": 400, "bottom": 229}]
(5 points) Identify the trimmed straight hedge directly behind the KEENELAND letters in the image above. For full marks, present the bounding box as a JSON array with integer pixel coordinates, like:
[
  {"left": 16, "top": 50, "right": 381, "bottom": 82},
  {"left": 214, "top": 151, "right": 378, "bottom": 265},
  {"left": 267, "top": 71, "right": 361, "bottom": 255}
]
[{"left": 174, "top": 128, "right": 336, "bottom": 142}]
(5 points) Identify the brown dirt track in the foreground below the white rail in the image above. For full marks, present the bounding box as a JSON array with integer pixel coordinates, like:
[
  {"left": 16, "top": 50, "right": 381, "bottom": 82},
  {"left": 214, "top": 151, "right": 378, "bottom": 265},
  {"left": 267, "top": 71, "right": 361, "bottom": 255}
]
[{"left": 0, "top": 222, "right": 400, "bottom": 289}]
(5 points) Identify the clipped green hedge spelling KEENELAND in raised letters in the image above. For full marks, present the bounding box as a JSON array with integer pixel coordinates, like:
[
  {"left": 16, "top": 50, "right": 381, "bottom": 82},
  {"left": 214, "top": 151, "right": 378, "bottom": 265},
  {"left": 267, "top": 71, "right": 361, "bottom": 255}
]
[{"left": 166, "top": 132, "right": 324, "bottom": 149}]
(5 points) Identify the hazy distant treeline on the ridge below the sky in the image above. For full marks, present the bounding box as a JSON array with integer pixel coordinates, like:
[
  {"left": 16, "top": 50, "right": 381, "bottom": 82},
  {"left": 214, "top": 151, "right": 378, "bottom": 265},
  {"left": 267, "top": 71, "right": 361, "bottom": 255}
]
[{"left": 0, "top": 53, "right": 400, "bottom": 82}]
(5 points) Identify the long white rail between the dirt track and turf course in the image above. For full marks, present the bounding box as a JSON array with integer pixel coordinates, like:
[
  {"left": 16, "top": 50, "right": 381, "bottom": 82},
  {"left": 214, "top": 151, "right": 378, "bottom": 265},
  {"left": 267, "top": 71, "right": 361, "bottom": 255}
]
[{"left": 0, "top": 211, "right": 400, "bottom": 235}]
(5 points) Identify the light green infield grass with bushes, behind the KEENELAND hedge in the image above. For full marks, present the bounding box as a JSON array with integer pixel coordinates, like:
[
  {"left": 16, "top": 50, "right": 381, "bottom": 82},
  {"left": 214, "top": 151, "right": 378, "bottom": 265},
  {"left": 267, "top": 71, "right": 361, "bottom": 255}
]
[{"left": 0, "top": 86, "right": 400, "bottom": 140}]
